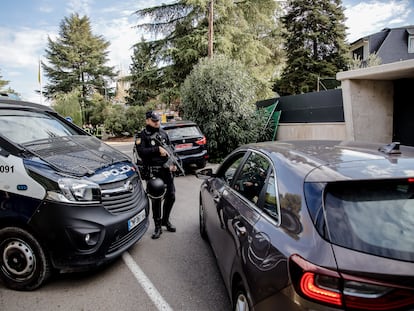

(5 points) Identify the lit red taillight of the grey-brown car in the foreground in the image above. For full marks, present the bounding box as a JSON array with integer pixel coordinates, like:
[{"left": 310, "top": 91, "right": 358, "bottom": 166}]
[{"left": 289, "top": 255, "right": 414, "bottom": 310}]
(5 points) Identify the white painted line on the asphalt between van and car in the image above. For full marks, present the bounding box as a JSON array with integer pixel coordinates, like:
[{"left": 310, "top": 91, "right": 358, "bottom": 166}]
[{"left": 122, "top": 252, "right": 173, "bottom": 311}]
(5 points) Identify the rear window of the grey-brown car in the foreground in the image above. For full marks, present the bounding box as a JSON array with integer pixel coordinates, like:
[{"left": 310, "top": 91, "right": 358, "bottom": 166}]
[{"left": 325, "top": 179, "right": 414, "bottom": 261}]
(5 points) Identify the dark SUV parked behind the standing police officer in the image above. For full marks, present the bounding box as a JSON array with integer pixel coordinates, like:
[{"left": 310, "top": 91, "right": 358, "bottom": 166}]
[{"left": 133, "top": 120, "right": 209, "bottom": 176}]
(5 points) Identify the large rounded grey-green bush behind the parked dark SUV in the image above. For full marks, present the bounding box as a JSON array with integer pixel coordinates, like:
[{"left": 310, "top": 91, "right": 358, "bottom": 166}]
[{"left": 181, "top": 55, "right": 264, "bottom": 161}]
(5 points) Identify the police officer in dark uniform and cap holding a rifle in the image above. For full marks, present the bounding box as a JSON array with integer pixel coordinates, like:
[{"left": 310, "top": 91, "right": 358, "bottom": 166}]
[{"left": 136, "top": 111, "right": 177, "bottom": 239}]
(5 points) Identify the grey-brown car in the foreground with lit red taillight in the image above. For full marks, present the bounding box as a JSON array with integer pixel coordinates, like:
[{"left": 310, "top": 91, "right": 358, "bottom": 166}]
[{"left": 197, "top": 141, "right": 414, "bottom": 310}]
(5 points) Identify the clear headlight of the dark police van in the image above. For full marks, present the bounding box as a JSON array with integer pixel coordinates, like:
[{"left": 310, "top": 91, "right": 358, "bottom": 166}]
[{"left": 47, "top": 178, "right": 101, "bottom": 203}]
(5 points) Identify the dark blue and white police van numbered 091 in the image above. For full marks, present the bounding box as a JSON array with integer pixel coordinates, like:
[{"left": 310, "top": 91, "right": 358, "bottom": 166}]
[{"left": 0, "top": 99, "right": 149, "bottom": 290}]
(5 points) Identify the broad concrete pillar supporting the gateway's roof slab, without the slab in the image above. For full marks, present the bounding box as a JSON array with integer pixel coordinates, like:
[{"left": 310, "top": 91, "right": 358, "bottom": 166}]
[{"left": 342, "top": 80, "right": 394, "bottom": 143}]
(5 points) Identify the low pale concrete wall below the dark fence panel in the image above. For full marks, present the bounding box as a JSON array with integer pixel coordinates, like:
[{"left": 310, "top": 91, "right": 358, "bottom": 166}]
[{"left": 276, "top": 122, "right": 347, "bottom": 140}]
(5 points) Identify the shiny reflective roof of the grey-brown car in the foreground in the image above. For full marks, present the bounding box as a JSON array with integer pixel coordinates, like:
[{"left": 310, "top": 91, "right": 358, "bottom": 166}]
[{"left": 241, "top": 140, "right": 414, "bottom": 182}]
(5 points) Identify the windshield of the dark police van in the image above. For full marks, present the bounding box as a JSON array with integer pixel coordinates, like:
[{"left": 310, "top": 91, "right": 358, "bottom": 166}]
[{"left": 0, "top": 109, "right": 79, "bottom": 144}]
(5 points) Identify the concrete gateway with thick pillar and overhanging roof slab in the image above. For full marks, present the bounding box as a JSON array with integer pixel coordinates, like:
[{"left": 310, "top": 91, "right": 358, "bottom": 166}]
[{"left": 336, "top": 60, "right": 414, "bottom": 143}]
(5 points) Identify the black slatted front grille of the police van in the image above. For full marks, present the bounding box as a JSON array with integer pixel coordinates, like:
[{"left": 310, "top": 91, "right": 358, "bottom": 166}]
[{"left": 101, "top": 178, "right": 142, "bottom": 215}]
